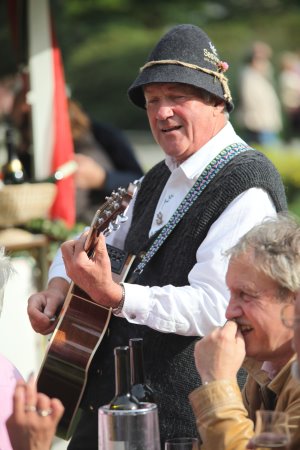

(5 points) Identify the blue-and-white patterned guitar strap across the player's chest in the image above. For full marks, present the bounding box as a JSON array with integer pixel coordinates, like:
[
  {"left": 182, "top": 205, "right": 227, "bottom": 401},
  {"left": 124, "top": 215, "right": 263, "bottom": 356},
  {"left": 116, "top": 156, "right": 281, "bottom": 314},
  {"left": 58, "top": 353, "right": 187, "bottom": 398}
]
[{"left": 133, "top": 143, "right": 251, "bottom": 275}]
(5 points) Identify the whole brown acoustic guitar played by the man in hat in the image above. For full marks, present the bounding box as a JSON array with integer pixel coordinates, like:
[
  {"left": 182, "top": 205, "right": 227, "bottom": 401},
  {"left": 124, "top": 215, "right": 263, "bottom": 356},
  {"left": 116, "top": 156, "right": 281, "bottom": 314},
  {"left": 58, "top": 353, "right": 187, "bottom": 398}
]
[{"left": 37, "top": 184, "right": 136, "bottom": 439}]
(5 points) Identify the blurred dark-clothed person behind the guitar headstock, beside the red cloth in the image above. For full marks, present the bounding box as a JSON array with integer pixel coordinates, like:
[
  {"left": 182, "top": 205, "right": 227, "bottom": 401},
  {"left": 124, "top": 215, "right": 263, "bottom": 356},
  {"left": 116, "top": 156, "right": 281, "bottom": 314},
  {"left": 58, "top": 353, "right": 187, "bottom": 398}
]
[{"left": 69, "top": 99, "right": 143, "bottom": 224}]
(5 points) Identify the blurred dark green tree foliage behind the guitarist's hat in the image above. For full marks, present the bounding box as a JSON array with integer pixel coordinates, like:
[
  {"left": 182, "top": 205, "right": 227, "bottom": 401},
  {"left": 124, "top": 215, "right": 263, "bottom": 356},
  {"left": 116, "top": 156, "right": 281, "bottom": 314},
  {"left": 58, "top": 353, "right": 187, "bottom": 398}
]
[{"left": 0, "top": 0, "right": 300, "bottom": 129}]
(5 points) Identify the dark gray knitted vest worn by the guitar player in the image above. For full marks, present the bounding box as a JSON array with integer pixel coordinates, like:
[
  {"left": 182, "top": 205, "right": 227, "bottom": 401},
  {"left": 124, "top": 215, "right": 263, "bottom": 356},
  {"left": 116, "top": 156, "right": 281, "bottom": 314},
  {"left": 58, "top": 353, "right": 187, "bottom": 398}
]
[{"left": 83, "top": 150, "right": 287, "bottom": 442}]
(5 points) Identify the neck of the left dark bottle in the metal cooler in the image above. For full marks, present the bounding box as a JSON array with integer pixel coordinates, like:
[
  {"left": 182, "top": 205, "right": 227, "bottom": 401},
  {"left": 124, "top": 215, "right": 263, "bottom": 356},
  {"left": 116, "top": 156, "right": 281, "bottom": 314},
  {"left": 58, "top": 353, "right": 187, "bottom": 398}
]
[{"left": 114, "top": 347, "right": 130, "bottom": 395}]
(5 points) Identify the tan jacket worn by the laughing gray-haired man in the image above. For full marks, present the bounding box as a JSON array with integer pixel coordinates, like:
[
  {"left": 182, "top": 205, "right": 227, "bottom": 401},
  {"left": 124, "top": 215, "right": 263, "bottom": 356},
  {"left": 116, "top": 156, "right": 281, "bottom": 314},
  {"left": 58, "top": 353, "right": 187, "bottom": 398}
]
[{"left": 189, "top": 357, "right": 300, "bottom": 450}]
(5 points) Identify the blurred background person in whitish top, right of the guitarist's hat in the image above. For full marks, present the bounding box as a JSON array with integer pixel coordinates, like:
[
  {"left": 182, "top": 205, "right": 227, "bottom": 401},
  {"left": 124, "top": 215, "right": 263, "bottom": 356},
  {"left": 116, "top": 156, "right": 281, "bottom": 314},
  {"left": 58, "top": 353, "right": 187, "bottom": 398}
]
[{"left": 236, "top": 41, "right": 282, "bottom": 145}]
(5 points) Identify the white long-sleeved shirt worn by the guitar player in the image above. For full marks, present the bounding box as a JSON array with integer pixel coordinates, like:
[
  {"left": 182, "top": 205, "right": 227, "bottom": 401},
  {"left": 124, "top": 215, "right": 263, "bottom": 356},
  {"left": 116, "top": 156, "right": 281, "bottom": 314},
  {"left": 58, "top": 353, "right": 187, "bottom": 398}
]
[{"left": 49, "top": 122, "right": 276, "bottom": 336}]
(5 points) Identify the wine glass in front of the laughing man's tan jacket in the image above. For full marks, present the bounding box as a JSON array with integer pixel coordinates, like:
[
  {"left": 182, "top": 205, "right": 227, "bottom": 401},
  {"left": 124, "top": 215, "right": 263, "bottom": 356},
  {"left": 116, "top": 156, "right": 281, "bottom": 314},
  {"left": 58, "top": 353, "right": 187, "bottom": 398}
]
[{"left": 253, "top": 410, "right": 290, "bottom": 450}]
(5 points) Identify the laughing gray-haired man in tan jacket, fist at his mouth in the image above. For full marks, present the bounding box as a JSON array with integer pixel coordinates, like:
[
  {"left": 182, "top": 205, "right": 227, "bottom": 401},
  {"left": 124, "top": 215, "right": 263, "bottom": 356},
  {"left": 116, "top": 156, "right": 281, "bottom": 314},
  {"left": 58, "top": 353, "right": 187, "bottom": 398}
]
[{"left": 190, "top": 215, "right": 300, "bottom": 450}]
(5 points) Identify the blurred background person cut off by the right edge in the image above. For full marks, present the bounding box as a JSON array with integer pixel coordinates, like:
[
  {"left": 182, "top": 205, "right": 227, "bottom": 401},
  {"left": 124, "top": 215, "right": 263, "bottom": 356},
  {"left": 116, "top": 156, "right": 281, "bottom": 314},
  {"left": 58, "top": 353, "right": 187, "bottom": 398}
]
[{"left": 279, "top": 52, "right": 300, "bottom": 143}]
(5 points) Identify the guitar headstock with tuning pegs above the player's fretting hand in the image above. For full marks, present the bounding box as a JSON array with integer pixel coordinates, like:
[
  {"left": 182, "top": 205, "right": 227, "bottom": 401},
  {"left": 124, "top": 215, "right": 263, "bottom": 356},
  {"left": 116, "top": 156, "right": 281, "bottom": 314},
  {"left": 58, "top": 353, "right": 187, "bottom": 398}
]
[{"left": 84, "top": 183, "right": 137, "bottom": 257}]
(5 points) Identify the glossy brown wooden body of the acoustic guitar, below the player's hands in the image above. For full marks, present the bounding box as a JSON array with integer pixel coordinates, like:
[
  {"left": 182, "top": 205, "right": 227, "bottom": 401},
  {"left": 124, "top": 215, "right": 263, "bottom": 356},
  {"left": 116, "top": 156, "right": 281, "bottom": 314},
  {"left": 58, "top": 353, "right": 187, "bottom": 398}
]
[{"left": 37, "top": 285, "right": 111, "bottom": 439}]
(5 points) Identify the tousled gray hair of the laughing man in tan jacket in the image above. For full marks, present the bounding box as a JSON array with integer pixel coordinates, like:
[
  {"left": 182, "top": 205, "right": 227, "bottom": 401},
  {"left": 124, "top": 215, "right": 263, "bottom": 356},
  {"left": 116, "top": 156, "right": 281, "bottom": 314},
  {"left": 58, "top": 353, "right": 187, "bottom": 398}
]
[{"left": 226, "top": 213, "right": 300, "bottom": 292}]
